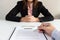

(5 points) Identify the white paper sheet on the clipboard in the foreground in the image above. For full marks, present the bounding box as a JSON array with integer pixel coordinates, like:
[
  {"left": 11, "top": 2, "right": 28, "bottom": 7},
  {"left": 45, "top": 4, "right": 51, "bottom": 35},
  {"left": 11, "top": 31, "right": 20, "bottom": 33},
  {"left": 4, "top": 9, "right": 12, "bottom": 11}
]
[{"left": 10, "top": 27, "right": 52, "bottom": 40}]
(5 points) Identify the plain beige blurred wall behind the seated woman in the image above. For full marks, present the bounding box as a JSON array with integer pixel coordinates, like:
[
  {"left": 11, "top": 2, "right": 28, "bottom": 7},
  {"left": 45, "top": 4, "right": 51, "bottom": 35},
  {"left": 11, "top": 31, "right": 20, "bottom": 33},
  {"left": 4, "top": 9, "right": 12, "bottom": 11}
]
[{"left": 0, "top": 0, "right": 60, "bottom": 20}]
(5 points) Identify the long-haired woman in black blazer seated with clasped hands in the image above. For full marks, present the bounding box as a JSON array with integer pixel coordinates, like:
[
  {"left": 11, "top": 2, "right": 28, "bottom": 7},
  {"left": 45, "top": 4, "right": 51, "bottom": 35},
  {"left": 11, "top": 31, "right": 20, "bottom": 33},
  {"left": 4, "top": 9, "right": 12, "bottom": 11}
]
[{"left": 6, "top": 0, "right": 54, "bottom": 22}]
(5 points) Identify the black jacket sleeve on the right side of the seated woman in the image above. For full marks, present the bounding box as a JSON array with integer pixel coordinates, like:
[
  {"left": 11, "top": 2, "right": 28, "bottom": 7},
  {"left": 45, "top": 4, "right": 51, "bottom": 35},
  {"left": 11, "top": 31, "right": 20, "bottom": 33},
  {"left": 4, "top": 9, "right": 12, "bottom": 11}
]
[{"left": 39, "top": 3, "right": 54, "bottom": 22}]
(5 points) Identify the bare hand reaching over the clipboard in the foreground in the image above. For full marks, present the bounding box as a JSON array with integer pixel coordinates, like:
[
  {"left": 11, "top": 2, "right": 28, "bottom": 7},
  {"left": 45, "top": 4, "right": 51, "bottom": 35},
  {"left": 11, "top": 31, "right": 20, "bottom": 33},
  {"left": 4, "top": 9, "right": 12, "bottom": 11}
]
[{"left": 38, "top": 23, "right": 55, "bottom": 36}]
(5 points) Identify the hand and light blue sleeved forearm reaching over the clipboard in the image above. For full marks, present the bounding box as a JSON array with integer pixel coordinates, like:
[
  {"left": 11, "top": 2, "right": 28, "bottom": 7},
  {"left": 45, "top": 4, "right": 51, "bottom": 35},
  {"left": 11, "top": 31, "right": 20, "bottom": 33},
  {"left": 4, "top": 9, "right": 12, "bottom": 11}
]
[{"left": 38, "top": 23, "right": 60, "bottom": 40}]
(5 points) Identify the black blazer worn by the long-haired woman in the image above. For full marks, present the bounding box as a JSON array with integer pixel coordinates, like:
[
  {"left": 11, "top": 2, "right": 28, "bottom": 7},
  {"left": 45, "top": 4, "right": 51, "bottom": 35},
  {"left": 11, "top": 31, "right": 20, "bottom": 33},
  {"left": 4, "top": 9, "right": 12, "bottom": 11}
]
[{"left": 6, "top": 1, "right": 54, "bottom": 22}]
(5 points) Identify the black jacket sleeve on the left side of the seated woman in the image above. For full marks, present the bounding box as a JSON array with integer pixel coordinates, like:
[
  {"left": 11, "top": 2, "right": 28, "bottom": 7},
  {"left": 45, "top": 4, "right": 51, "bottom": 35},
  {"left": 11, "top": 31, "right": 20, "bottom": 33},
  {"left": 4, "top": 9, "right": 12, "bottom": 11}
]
[{"left": 6, "top": 2, "right": 21, "bottom": 22}]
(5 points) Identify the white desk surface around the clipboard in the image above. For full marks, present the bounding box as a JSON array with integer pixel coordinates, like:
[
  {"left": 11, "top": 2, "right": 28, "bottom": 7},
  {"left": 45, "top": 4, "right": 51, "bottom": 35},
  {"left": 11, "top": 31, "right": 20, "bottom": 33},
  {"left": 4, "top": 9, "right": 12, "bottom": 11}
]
[{"left": 0, "top": 19, "right": 60, "bottom": 40}]
